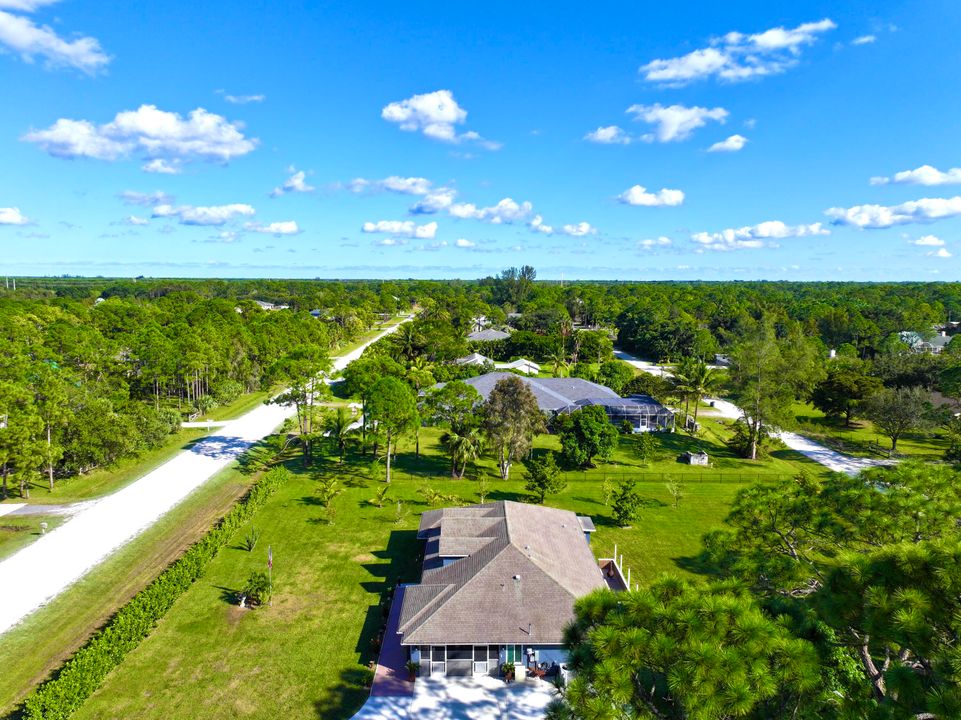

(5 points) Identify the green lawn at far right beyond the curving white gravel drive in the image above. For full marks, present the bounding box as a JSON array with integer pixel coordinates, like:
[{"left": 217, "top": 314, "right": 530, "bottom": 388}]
[{"left": 794, "top": 403, "right": 949, "bottom": 460}]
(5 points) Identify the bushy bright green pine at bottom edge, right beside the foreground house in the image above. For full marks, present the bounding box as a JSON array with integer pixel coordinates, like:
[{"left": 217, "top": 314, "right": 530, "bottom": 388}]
[{"left": 564, "top": 576, "right": 821, "bottom": 720}]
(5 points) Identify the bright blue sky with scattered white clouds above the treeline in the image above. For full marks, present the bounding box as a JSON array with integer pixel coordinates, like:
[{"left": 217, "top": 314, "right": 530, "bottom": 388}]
[{"left": 0, "top": 0, "right": 961, "bottom": 280}]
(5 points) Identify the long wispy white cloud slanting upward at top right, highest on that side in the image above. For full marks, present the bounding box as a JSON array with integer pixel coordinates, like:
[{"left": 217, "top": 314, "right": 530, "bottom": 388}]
[{"left": 640, "top": 18, "right": 837, "bottom": 86}]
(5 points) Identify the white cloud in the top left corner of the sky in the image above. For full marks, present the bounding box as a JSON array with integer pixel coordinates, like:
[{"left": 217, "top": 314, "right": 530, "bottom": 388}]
[{"left": 0, "top": 0, "right": 110, "bottom": 75}]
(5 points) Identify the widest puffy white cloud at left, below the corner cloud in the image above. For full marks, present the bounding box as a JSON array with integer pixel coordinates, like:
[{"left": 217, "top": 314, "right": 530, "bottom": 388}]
[{"left": 22, "top": 105, "right": 258, "bottom": 171}]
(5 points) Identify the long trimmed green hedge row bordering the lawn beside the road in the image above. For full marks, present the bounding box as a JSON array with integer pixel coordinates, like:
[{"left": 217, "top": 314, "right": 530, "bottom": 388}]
[{"left": 22, "top": 467, "right": 290, "bottom": 720}]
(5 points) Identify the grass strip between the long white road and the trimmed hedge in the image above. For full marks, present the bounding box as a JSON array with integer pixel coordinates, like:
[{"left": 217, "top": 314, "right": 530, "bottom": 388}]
[{"left": 0, "top": 462, "right": 250, "bottom": 715}]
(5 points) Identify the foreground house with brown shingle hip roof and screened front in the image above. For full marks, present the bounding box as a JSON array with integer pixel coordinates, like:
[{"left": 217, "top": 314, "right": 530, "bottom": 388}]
[{"left": 398, "top": 500, "right": 607, "bottom": 677}]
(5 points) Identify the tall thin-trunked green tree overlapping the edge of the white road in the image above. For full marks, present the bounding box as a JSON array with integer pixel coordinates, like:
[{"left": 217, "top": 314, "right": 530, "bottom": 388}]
[{"left": 269, "top": 345, "right": 330, "bottom": 465}]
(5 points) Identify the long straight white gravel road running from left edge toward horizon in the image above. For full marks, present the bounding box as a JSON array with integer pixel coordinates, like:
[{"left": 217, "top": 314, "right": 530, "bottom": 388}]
[{"left": 0, "top": 318, "right": 410, "bottom": 634}]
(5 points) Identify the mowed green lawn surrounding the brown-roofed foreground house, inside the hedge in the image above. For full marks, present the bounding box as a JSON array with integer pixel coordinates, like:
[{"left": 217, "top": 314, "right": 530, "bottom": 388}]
[{"left": 76, "top": 431, "right": 791, "bottom": 720}]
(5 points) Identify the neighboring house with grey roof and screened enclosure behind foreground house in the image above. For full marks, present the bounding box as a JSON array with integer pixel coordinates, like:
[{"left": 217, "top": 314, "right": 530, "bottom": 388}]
[{"left": 454, "top": 372, "right": 674, "bottom": 432}]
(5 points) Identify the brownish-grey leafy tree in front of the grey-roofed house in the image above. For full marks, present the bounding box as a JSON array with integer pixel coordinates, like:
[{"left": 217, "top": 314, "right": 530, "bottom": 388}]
[{"left": 484, "top": 375, "right": 545, "bottom": 480}]
